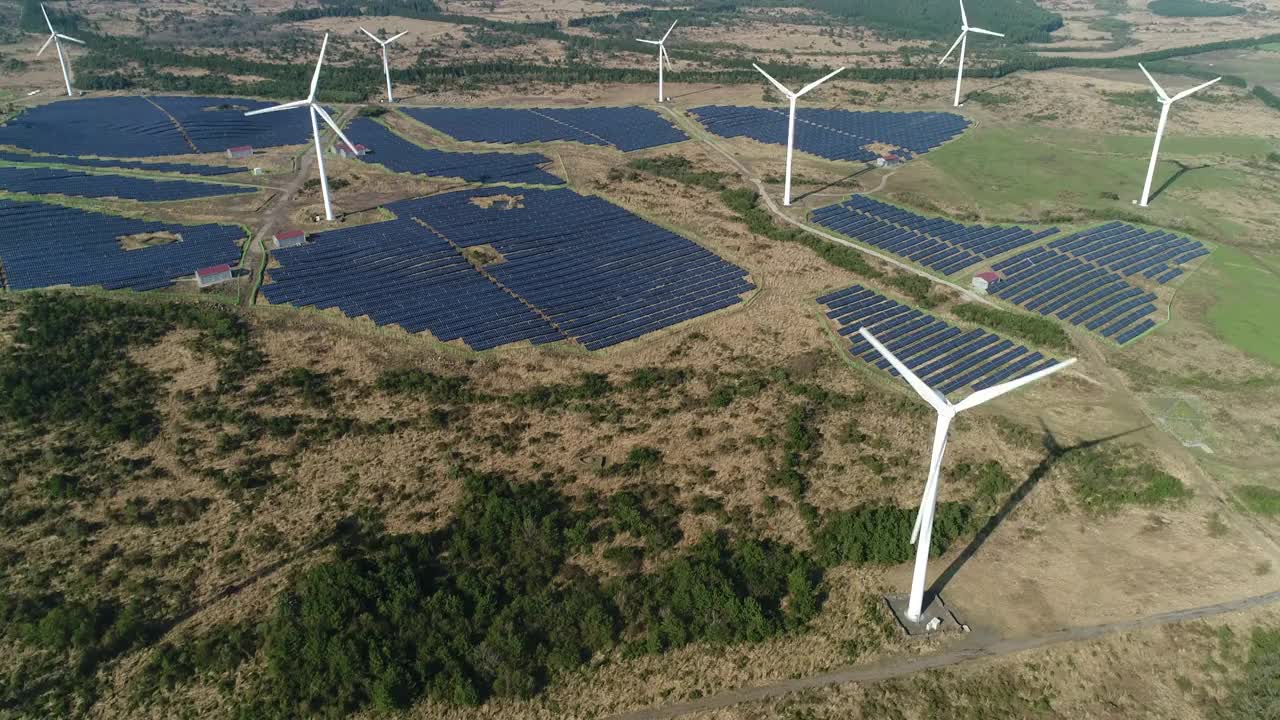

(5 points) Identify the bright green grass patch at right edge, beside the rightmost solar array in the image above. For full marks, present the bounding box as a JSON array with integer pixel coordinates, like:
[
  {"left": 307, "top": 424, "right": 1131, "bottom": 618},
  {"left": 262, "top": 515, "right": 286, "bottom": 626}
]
[{"left": 1208, "top": 247, "right": 1280, "bottom": 366}]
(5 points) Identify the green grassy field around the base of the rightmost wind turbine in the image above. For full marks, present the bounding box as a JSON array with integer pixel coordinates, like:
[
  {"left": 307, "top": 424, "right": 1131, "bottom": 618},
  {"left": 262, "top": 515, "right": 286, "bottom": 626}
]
[{"left": 890, "top": 126, "right": 1274, "bottom": 242}]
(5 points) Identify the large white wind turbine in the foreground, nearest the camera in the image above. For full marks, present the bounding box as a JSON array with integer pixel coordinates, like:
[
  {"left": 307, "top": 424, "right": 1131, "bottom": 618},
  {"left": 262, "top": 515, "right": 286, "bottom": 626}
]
[{"left": 860, "top": 328, "right": 1075, "bottom": 623}]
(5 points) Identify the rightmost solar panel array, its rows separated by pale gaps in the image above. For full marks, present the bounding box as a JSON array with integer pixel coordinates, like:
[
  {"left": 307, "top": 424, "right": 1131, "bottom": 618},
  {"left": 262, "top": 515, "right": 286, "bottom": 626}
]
[{"left": 988, "top": 222, "right": 1210, "bottom": 345}]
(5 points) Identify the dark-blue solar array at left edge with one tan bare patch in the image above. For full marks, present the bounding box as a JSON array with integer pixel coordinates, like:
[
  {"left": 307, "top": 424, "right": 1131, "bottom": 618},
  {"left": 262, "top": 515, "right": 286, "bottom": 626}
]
[{"left": 0, "top": 200, "right": 244, "bottom": 291}]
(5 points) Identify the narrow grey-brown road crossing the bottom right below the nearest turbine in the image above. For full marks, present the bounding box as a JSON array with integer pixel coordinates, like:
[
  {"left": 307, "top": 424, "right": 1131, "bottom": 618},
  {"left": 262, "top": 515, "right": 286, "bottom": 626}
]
[{"left": 607, "top": 591, "right": 1280, "bottom": 720}]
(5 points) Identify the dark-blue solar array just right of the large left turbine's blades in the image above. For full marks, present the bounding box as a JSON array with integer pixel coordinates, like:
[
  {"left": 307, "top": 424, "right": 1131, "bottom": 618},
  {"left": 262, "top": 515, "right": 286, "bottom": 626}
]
[{"left": 347, "top": 118, "right": 564, "bottom": 184}]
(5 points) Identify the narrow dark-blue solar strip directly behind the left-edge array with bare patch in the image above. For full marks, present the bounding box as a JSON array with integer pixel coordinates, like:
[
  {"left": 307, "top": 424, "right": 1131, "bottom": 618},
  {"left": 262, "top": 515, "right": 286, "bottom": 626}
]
[{"left": 0, "top": 167, "right": 256, "bottom": 202}]
